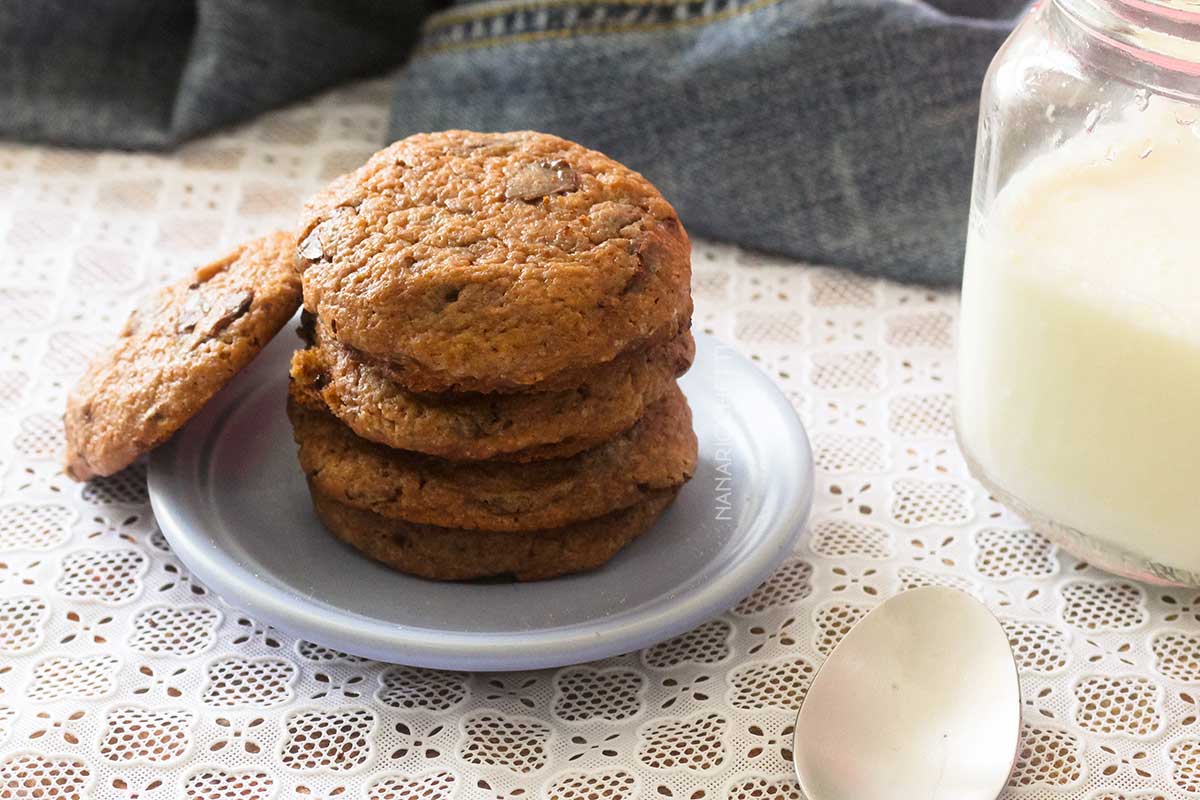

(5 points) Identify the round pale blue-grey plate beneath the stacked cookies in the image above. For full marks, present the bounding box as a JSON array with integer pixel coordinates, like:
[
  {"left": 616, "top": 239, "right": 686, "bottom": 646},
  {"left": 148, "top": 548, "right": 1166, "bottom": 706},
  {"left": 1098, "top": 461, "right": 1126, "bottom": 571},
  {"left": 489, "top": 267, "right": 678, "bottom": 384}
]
[{"left": 150, "top": 336, "right": 812, "bottom": 670}]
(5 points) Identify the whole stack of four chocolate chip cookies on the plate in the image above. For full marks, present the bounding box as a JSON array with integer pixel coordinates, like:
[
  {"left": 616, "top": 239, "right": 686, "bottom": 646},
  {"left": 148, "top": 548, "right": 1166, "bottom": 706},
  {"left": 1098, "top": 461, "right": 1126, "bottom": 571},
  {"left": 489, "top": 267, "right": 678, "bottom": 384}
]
[{"left": 288, "top": 131, "right": 696, "bottom": 579}]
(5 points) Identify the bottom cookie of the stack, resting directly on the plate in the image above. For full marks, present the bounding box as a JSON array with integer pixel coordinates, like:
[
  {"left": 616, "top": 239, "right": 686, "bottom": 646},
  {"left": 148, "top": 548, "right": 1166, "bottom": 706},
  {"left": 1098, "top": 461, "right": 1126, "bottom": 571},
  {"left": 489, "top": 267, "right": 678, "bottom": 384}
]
[{"left": 312, "top": 489, "right": 676, "bottom": 581}]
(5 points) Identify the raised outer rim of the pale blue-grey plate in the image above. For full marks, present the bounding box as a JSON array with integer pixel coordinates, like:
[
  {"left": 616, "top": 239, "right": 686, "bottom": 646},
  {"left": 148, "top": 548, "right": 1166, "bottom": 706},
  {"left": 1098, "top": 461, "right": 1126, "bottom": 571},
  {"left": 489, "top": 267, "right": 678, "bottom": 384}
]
[{"left": 148, "top": 332, "right": 815, "bottom": 672}]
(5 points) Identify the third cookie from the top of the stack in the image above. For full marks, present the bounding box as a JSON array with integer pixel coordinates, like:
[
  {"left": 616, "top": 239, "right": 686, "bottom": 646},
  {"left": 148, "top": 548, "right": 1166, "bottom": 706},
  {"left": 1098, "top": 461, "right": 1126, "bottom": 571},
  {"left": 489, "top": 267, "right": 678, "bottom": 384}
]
[{"left": 288, "top": 387, "right": 696, "bottom": 531}]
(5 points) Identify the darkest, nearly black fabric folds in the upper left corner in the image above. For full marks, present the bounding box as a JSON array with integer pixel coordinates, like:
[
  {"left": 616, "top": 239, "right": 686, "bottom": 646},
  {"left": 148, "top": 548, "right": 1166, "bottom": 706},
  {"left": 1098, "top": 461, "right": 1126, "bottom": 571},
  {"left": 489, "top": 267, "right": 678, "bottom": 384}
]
[{"left": 0, "top": 0, "right": 430, "bottom": 149}]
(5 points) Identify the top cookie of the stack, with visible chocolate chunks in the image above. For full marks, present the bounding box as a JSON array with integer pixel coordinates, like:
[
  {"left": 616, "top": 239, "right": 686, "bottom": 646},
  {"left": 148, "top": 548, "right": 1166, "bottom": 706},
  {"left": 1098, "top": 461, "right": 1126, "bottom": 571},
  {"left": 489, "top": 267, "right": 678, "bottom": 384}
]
[{"left": 298, "top": 131, "right": 691, "bottom": 392}]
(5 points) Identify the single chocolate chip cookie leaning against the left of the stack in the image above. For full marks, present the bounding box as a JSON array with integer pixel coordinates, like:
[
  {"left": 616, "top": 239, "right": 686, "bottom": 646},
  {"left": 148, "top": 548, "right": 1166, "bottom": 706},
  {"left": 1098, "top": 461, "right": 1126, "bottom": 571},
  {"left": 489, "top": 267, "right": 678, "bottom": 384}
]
[{"left": 64, "top": 233, "right": 300, "bottom": 481}]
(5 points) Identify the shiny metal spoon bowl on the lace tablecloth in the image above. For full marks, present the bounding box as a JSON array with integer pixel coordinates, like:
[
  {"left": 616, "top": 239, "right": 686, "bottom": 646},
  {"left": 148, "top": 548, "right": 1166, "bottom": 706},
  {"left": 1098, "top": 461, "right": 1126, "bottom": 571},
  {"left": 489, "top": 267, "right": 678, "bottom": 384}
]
[{"left": 792, "top": 588, "right": 1021, "bottom": 800}]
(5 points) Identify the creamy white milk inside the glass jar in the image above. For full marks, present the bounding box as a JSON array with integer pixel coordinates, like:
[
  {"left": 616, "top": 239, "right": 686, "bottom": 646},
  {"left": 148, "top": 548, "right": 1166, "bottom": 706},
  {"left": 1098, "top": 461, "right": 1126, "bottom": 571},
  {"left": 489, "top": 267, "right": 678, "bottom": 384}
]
[{"left": 958, "top": 103, "right": 1200, "bottom": 582}]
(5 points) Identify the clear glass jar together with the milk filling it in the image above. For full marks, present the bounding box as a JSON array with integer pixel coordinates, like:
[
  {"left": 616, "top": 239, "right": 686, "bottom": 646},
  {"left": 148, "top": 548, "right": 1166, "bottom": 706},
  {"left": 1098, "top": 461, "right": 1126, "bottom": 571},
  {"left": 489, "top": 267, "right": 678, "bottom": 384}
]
[{"left": 958, "top": 0, "right": 1200, "bottom": 584}]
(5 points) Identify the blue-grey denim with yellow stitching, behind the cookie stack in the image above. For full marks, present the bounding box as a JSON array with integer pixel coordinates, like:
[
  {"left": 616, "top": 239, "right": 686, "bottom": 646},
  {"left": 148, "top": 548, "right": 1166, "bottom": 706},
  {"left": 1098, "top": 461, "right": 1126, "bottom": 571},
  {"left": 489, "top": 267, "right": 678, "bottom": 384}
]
[{"left": 392, "top": 0, "right": 1019, "bottom": 283}]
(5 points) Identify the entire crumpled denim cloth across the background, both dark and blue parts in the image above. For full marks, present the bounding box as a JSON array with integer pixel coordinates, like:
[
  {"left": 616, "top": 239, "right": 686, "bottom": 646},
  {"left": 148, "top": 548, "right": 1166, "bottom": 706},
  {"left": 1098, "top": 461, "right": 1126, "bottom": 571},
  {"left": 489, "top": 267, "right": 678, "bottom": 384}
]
[{"left": 0, "top": 0, "right": 1022, "bottom": 283}]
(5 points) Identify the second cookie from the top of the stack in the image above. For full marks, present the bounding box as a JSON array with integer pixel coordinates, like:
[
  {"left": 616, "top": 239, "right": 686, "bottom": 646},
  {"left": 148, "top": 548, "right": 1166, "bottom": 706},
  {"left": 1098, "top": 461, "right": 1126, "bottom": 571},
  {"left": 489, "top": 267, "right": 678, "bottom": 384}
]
[{"left": 292, "top": 323, "right": 695, "bottom": 461}]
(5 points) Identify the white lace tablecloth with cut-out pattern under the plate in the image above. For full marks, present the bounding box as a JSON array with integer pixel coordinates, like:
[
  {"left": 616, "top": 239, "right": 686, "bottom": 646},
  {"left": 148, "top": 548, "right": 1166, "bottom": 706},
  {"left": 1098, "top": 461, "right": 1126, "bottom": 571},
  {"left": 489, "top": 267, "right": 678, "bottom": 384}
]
[{"left": 0, "top": 76, "right": 1200, "bottom": 800}]
